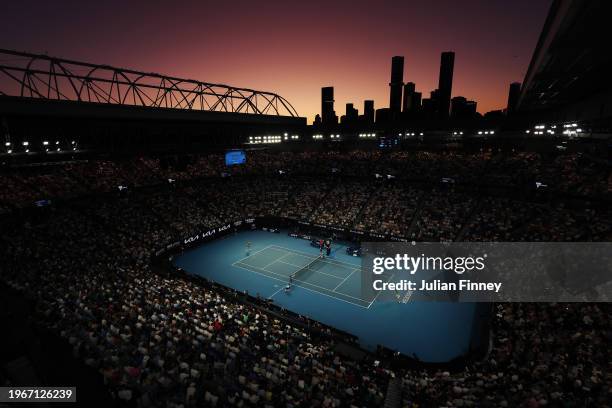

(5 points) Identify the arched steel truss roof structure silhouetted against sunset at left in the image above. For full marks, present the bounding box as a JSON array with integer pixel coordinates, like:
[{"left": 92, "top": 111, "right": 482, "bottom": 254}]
[{"left": 0, "top": 49, "right": 299, "bottom": 117}]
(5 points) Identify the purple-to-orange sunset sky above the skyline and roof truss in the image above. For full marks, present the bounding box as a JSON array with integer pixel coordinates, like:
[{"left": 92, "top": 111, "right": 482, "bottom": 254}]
[{"left": 0, "top": 0, "right": 551, "bottom": 123}]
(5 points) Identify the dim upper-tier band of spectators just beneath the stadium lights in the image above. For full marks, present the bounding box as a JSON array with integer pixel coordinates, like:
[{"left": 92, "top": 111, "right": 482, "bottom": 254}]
[{"left": 0, "top": 149, "right": 612, "bottom": 207}]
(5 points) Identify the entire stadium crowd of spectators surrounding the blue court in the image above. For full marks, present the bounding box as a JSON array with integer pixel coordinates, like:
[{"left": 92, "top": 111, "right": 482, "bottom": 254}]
[{"left": 0, "top": 151, "right": 612, "bottom": 408}]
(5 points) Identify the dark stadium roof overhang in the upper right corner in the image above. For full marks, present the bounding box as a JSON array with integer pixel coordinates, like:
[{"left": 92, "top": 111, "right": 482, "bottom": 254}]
[{"left": 518, "top": 0, "right": 612, "bottom": 112}]
